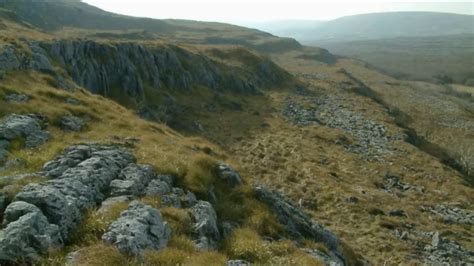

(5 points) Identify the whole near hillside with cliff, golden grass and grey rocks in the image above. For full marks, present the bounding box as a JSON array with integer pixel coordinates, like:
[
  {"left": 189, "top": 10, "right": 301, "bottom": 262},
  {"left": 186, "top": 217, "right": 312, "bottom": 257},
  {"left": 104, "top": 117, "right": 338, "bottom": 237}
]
[{"left": 0, "top": 2, "right": 474, "bottom": 265}]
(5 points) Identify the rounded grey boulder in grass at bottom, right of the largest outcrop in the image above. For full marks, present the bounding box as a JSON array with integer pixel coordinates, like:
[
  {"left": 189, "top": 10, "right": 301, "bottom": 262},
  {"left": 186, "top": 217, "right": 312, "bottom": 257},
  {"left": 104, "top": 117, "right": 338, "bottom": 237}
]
[{"left": 102, "top": 201, "right": 171, "bottom": 256}]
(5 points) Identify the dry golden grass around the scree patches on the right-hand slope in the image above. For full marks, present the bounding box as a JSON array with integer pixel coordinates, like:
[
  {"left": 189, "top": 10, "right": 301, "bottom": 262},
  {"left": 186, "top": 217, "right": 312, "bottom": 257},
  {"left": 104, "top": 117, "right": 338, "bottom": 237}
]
[{"left": 214, "top": 52, "right": 473, "bottom": 264}]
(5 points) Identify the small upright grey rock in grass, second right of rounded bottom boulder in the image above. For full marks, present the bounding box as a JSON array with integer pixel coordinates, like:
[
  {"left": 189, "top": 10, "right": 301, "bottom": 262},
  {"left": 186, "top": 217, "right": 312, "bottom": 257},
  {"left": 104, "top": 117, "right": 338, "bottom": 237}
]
[{"left": 191, "top": 201, "right": 220, "bottom": 251}]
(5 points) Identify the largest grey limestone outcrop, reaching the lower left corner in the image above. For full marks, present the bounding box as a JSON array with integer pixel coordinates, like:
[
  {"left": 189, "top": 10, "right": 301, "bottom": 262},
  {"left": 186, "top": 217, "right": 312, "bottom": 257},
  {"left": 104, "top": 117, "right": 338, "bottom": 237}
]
[{"left": 0, "top": 144, "right": 134, "bottom": 261}]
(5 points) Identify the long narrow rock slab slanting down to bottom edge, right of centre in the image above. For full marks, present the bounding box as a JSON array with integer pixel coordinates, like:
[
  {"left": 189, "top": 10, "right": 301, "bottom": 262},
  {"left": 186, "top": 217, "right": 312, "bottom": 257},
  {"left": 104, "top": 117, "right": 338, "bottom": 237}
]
[{"left": 254, "top": 186, "right": 347, "bottom": 265}]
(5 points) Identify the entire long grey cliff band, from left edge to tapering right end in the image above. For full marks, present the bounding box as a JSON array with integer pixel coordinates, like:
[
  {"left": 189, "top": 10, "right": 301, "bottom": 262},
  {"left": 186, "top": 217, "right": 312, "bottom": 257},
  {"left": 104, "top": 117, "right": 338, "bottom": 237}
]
[{"left": 0, "top": 41, "right": 289, "bottom": 98}]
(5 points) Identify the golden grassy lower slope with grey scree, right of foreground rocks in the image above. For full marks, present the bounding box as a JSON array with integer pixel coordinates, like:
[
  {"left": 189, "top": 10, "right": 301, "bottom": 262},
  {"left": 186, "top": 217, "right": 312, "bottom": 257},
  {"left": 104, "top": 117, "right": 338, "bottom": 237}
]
[{"left": 194, "top": 51, "right": 474, "bottom": 265}]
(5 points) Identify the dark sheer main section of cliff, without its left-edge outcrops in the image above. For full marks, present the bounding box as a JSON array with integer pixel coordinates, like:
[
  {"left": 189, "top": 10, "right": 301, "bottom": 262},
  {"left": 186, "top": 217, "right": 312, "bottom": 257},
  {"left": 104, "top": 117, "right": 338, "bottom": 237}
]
[{"left": 43, "top": 41, "right": 286, "bottom": 97}]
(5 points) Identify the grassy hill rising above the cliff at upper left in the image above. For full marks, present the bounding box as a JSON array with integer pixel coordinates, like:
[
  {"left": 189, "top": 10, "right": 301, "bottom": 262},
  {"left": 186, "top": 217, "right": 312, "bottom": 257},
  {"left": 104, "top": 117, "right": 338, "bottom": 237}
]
[{"left": 0, "top": 0, "right": 301, "bottom": 52}]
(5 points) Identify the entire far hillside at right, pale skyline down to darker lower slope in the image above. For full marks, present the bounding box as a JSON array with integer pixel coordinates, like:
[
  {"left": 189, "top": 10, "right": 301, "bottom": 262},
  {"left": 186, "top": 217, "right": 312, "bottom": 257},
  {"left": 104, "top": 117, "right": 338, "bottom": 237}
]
[{"left": 250, "top": 12, "right": 474, "bottom": 84}]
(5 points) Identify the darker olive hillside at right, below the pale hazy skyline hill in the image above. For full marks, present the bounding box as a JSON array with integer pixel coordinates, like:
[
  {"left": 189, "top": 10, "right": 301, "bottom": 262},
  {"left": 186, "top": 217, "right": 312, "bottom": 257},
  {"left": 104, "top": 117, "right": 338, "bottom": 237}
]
[{"left": 314, "top": 34, "right": 474, "bottom": 84}]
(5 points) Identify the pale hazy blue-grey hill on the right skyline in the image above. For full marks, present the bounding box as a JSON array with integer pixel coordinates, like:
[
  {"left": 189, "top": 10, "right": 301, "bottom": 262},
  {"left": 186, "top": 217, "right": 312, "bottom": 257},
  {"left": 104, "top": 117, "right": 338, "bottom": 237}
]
[{"left": 257, "top": 12, "right": 474, "bottom": 44}]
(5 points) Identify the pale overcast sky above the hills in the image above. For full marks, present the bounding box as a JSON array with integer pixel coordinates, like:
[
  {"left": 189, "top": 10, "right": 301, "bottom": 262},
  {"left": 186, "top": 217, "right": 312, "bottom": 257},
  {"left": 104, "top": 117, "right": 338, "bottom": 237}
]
[{"left": 83, "top": 0, "right": 474, "bottom": 22}]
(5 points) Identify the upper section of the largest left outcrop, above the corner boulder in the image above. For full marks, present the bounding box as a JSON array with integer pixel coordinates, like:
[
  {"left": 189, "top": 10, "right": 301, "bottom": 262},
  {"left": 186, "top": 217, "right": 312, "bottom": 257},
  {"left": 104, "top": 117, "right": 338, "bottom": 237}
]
[{"left": 15, "top": 144, "right": 134, "bottom": 239}]
